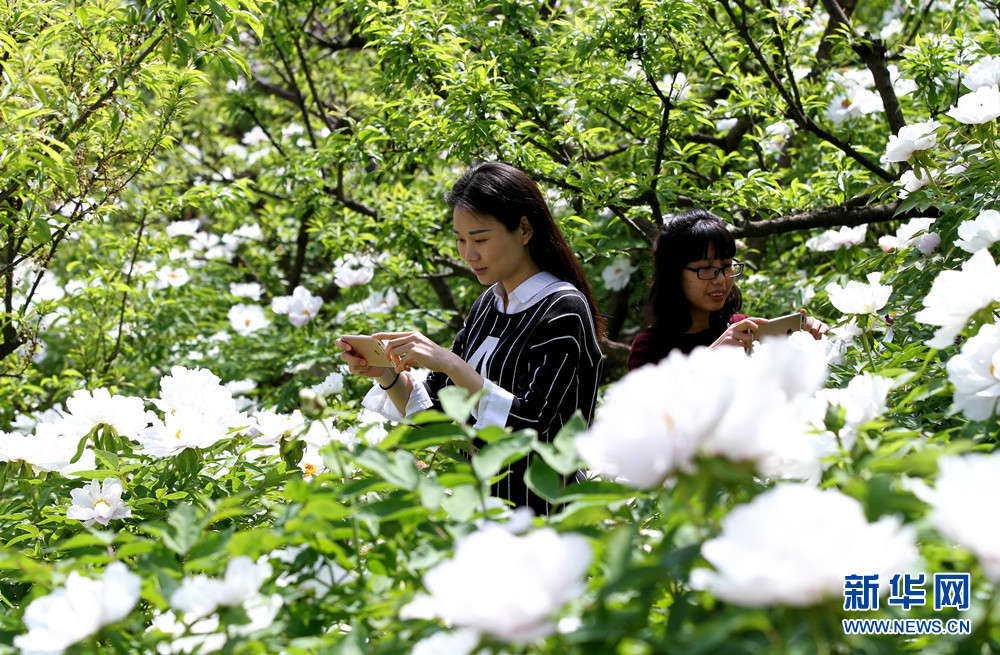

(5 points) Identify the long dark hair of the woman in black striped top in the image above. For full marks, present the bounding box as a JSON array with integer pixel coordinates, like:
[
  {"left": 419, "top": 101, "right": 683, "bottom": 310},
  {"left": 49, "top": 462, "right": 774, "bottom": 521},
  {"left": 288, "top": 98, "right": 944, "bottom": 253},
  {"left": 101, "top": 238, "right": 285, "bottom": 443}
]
[{"left": 445, "top": 162, "right": 604, "bottom": 338}]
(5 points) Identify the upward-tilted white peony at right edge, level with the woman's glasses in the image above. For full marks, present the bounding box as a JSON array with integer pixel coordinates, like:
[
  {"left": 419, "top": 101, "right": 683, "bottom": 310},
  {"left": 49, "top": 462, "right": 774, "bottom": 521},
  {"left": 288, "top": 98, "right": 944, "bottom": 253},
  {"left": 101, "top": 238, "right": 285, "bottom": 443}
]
[{"left": 914, "top": 249, "right": 1000, "bottom": 348}]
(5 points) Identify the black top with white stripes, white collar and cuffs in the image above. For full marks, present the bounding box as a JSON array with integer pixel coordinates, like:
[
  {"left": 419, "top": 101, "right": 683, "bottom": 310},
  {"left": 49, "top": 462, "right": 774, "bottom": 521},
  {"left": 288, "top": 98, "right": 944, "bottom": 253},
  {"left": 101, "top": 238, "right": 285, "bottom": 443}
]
[{"left": 365, "top": 273, "right": 603, "bottom": 514}]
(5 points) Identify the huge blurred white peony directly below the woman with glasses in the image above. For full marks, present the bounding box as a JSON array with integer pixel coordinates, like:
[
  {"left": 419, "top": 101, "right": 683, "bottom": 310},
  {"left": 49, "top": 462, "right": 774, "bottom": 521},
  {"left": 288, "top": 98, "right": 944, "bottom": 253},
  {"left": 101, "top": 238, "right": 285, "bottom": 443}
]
[{"left": 574, "top": 334, "right": 830, "bottom": 489}]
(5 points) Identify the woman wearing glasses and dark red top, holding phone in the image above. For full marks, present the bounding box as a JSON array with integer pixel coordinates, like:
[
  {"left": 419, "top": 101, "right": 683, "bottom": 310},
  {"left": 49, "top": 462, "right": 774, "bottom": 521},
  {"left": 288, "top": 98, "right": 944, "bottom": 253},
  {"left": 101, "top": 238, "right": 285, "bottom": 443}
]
[{"left": 627, "top": 209, "right": 827, "bottom": 371}]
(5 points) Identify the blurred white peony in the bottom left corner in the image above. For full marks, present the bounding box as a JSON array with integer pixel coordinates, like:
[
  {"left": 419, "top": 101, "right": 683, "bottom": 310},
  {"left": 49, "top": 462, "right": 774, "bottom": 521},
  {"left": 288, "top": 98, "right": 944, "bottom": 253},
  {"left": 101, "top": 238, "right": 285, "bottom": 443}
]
[{"left": 14, "top": 562, "right": 142, "bottom": 654}]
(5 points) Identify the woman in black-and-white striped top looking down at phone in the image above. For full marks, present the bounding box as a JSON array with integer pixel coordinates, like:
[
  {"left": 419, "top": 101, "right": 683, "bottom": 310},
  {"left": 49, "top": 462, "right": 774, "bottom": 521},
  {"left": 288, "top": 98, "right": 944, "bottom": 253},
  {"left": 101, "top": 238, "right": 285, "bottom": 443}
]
[{"left": 337, "top": 162, "right": 602, "bottom": 514}]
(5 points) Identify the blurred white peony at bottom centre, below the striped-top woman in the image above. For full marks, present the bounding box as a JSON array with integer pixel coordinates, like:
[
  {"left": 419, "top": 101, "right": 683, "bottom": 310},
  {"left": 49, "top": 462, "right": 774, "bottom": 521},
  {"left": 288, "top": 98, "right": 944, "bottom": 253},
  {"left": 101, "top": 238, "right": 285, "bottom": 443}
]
[{"left": 400, "top": 523, "right": 592, "bottom": 643}]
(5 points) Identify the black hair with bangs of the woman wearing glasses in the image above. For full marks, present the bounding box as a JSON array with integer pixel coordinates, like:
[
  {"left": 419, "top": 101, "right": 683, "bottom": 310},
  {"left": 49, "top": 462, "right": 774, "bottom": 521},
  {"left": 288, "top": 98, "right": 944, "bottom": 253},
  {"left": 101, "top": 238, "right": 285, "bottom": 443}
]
[{"left": 645, "top": 209, "right": 743, "bottom": 334}]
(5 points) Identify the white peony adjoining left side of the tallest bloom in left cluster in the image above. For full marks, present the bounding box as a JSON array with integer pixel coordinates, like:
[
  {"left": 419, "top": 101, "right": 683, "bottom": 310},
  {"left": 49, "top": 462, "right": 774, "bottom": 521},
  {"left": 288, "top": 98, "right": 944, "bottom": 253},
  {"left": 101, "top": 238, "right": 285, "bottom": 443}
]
[{"left": 59, "top": 388, "right": 155, "bottom": 439}]
